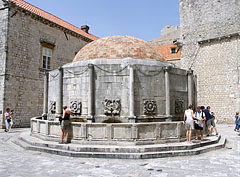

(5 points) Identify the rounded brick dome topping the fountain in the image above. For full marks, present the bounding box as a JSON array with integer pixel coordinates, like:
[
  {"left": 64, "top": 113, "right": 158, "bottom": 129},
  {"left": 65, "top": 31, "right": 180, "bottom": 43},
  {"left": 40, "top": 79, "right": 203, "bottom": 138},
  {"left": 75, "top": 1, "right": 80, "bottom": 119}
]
[{"left": 73, "top": 36, "right": 164, "bottom": 62}]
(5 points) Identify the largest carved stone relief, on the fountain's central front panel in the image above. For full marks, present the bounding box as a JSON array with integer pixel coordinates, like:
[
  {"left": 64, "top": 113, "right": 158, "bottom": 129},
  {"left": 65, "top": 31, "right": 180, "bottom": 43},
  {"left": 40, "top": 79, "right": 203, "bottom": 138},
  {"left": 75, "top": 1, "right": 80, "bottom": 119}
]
[{"left": 104, "top": 99, "right": 121, "bottom": 115}]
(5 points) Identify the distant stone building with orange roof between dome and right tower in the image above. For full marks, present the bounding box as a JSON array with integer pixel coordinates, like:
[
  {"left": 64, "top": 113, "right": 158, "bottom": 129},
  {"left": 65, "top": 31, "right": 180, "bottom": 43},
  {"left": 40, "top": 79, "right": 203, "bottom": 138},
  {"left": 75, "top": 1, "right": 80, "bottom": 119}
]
[{"left": 149, "top": 25, "right": 181, "bottom": 66}]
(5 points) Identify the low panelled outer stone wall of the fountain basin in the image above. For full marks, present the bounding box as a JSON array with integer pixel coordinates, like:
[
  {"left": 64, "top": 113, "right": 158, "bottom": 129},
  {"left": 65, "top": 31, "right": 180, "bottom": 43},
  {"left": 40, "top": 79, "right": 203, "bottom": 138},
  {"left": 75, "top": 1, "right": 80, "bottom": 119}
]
[{"left": 31, "top": 117, "right": 185, "bottom": 145}]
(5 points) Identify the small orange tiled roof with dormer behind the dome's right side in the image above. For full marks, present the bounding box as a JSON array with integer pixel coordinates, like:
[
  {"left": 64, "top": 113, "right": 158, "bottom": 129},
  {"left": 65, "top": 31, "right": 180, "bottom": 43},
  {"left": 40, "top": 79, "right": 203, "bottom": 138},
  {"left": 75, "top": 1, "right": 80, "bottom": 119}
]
[{"left": 155, "top": 44, "right": 181, "bottom": 60}]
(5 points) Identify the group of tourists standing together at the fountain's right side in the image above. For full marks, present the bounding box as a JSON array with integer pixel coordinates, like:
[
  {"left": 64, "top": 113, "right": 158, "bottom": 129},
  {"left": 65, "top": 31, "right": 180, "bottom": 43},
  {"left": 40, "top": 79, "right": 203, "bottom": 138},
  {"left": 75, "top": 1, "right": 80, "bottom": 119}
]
[{"left": 184, "top": 105, "right": 218, "bottom": 143}]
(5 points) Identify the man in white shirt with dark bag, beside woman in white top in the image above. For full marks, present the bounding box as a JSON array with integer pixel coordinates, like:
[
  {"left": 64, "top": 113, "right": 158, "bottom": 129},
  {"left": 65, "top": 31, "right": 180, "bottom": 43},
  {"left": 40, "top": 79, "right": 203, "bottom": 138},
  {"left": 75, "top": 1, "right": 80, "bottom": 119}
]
[{"left": 194, "top": 106, "right": 206, "bottom": 141}]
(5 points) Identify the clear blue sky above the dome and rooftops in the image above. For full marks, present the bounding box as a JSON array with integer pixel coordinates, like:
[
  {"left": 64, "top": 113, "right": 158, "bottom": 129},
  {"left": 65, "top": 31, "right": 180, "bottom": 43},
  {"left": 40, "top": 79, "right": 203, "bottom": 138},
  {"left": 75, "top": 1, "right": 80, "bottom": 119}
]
[{"left": 25, "top": 0, "right": 179, "bottom": 41}]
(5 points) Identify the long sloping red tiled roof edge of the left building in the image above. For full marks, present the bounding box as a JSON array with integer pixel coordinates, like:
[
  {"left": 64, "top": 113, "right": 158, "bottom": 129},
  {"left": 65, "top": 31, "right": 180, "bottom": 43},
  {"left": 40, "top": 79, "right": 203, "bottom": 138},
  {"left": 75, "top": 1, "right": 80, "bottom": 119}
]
[{"left": 9, "top": 0, "right": 98, "bottom": 40}]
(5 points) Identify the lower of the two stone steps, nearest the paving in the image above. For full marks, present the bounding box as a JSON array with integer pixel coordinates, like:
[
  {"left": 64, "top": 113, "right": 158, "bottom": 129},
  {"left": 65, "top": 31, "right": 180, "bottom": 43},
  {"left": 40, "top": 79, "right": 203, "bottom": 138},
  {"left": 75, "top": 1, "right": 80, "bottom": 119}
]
[{"left": 14, "top": 137, "right": 226, "bottom": 159}]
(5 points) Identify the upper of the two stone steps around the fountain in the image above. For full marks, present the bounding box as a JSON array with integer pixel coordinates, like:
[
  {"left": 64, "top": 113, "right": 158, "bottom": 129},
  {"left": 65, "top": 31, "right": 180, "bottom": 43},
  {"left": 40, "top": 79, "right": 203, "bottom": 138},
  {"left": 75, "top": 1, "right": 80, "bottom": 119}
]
[{"left": 16, "top": 133, "right": 221, "bottom": 153}]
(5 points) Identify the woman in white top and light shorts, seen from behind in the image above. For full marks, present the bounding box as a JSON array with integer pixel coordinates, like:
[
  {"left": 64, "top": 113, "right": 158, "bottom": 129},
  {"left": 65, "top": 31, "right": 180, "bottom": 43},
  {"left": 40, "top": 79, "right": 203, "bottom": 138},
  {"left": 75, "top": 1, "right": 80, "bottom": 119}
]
[{"left": 184, "top": 105, "right": 194, "bottom": 143}]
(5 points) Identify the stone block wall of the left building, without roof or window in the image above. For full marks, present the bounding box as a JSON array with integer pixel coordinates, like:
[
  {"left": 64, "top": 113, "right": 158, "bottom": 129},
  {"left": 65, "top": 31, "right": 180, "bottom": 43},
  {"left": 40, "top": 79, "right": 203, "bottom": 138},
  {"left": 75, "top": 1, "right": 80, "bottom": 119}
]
[{"left": 0, "top": 5, "right": 87, "bottom": 127}]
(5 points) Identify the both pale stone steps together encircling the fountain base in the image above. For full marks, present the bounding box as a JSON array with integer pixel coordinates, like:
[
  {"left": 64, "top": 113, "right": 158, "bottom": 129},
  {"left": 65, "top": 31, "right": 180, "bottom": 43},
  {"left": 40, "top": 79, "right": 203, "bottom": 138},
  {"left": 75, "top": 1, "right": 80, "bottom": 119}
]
[{"left": 13, "top": 131, "right": 226, "bottom": 159}]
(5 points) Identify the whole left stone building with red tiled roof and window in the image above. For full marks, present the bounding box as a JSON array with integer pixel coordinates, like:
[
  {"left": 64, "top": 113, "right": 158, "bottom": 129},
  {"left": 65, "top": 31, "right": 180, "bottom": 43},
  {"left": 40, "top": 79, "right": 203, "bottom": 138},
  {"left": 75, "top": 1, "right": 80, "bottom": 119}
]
[{"left": 0, "top": 0, "right": 97, "bottom": 127}]
